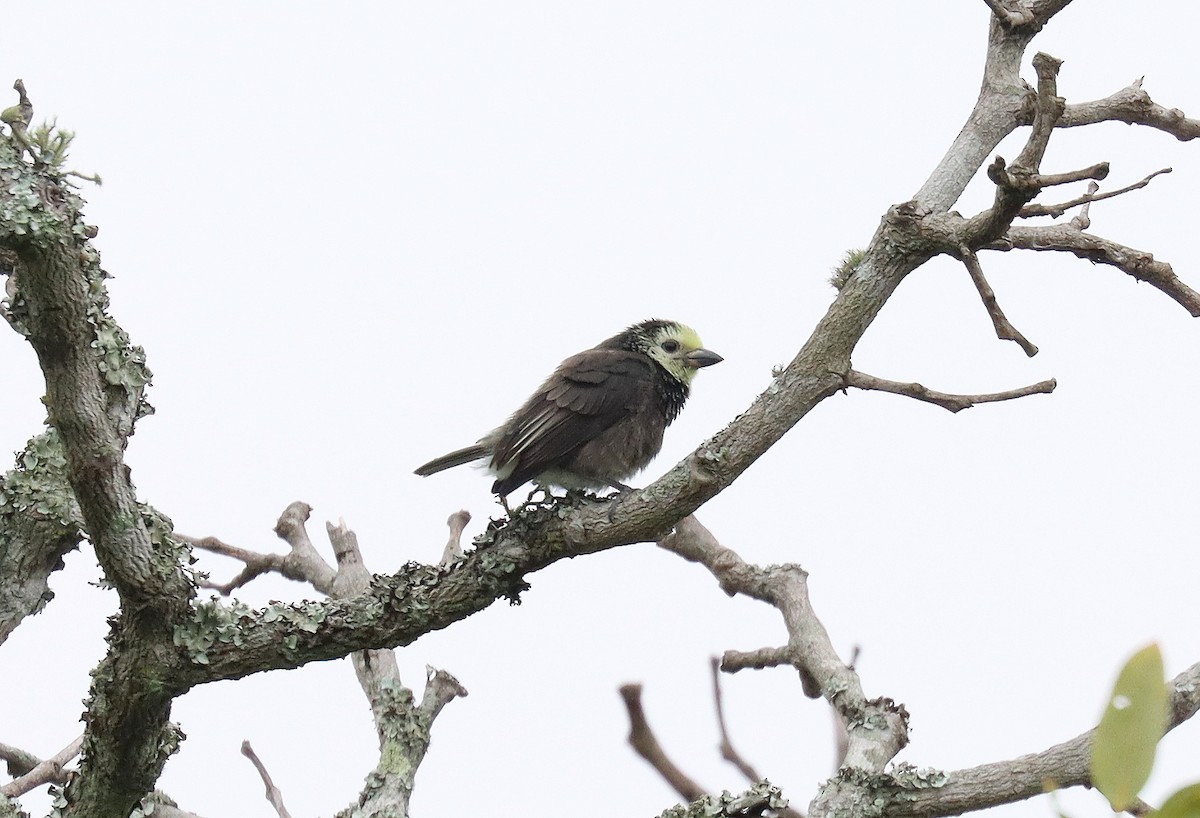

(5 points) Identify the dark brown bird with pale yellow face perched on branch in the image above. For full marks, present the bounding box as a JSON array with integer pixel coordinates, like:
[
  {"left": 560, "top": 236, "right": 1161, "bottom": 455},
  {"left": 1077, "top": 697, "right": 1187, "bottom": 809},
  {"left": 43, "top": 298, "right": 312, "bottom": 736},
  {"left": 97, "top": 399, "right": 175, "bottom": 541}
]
[{"left": 414, "top": 318, "right": 724, "bottom": 501}]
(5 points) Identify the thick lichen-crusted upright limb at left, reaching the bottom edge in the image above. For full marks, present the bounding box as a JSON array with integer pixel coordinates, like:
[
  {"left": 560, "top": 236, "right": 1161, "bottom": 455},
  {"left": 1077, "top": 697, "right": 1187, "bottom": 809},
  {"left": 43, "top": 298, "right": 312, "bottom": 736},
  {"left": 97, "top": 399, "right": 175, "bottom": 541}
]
[{"left": 0, "top": 85, "right": 193, "bottom": 817}]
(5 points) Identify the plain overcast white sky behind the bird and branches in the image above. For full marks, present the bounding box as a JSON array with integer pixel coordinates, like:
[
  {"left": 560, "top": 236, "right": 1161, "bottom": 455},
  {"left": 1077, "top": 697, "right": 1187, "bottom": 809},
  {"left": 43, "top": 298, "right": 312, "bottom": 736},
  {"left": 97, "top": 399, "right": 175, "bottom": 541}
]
[{"left": 0, "top": 0, "right": 1200, "bottom": 818}]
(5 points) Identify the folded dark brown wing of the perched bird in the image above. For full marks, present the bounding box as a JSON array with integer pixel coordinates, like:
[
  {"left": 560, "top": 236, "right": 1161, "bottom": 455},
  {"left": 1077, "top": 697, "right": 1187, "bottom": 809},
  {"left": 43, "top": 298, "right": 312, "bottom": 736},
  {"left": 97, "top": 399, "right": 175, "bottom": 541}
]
[{"left": 492, "top": 349, "right": 655, "bottom": 491}]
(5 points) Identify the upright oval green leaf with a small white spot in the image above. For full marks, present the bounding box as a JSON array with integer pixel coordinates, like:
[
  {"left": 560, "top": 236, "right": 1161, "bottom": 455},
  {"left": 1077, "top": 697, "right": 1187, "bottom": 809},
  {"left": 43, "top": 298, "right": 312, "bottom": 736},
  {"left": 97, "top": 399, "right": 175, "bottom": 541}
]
[{"left": 1092, "top": 644, "right": 1166, "bottom": 812}]
